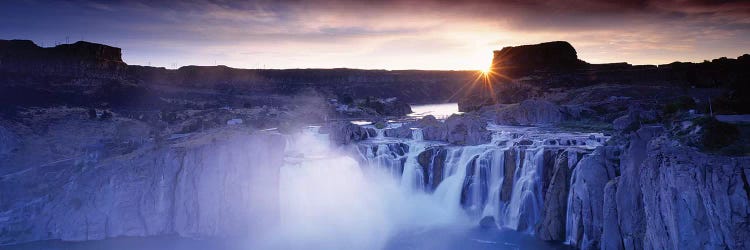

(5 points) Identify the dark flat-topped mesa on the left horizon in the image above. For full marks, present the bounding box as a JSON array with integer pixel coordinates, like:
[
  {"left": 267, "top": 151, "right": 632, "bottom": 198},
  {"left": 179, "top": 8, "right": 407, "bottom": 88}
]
[{"left": 0, "top": 40, "right": 127, "bottom": 77}]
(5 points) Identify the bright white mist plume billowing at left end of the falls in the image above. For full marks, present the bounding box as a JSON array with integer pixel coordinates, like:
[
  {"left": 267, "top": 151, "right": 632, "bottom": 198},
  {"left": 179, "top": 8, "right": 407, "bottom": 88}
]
[{"left": 274, "top": 129, "right": 466, "bottom": 249}]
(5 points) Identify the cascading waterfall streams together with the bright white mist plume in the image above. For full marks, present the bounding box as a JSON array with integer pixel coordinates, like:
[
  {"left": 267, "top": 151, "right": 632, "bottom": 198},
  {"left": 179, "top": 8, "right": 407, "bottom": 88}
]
[{"left": 271, "top": 124, "right": 608, "bottom": 249}]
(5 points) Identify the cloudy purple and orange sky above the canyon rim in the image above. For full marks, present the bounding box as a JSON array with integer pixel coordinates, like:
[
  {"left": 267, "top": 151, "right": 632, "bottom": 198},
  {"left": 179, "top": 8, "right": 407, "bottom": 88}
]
[{"left": 0, "top": 0, "right": 750, "bottom": 70}]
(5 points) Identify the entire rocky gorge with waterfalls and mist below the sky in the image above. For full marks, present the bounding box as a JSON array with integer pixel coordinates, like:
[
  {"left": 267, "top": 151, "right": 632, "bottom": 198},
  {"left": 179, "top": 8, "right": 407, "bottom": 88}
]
[{"left": 0, "top": 41, "right": 750, "bottom": 249}]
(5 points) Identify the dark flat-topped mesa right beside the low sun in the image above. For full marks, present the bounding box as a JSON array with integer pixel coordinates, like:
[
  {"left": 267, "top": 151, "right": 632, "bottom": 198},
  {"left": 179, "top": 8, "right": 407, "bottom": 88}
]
[{"left": 492, "top": 41, "right": 587, "bottom": 78}]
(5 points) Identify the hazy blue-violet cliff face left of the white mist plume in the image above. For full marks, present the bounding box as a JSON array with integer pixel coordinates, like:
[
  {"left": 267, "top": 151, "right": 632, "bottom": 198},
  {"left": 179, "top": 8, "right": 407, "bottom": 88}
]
[{"left": 0, "top": 131, "right": 284, "bottom": 244}]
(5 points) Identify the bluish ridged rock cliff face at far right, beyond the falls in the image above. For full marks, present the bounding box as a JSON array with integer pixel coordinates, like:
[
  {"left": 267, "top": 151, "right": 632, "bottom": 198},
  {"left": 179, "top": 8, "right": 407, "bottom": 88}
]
[{"left": 640, "top": 137, "right": 750, "bottom": 249}]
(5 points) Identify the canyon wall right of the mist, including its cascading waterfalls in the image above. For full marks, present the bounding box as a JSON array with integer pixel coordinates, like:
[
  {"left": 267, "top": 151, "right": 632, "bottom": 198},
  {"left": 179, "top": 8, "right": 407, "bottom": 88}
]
[{"left": 340, "top": 120, "right": 750, "bottom": 249}]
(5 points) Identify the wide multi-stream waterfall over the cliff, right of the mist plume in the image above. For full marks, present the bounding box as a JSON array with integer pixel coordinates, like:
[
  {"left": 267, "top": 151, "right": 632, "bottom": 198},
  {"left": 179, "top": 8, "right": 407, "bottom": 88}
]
[{"left": 350, "top": 124, "right": 604, "bottom": 239}]
